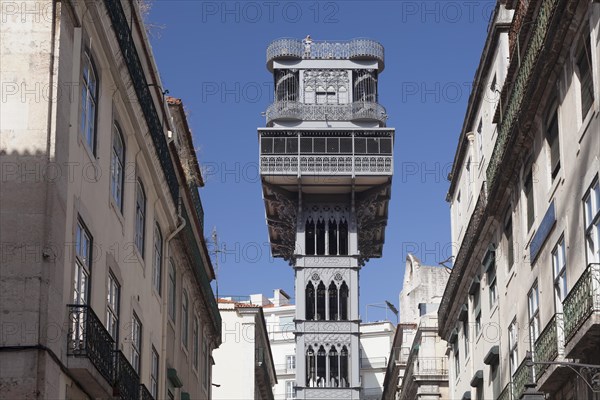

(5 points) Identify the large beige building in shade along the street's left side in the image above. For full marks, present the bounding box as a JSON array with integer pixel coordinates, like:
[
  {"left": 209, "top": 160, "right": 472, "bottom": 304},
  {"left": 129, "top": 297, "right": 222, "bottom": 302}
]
[{"left": 0, "top": 1, "right": 221, "bottom": 399}]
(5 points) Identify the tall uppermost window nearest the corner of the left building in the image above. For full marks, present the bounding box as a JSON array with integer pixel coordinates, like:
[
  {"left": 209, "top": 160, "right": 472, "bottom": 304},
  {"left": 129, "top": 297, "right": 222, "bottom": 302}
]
[{"left": 79, "top": 50, "right": 99, "bottom": 153}]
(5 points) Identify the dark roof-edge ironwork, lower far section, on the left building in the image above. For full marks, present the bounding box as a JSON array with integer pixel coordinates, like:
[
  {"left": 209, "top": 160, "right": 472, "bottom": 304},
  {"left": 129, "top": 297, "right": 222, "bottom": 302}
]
[{"left": 181, "top": 209, "right": 221, "bottom": 336}]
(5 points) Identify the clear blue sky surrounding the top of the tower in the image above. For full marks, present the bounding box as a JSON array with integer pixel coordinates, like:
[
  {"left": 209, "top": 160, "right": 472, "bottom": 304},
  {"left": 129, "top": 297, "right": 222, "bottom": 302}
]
[{"left": 148, "top": 0, "right": 495, "bottom": 320}]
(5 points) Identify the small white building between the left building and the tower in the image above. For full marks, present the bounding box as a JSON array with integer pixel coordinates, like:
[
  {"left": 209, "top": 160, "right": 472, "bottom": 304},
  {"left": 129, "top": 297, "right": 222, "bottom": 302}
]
[{"left": 213, "top": 299, "right": 277, "bottom": 400}]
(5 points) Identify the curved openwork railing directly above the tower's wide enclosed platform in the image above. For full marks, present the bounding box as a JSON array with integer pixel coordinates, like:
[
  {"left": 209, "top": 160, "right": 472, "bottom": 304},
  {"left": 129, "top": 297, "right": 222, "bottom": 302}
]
[{"left": 266, "top": 101, "right": 387, "bottom": 124}]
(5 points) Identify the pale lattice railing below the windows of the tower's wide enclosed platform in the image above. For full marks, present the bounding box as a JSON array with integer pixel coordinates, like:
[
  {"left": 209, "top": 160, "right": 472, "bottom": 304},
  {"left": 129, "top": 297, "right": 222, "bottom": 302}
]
[{"left": 260, "top": 155, "right": 394, "bottom": 175}]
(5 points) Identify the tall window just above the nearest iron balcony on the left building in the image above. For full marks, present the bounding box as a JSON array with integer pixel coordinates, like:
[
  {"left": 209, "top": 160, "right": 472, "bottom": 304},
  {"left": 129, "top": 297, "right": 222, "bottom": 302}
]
[{"left": 73, "top": 220, "right": 92, "bottom": 304}]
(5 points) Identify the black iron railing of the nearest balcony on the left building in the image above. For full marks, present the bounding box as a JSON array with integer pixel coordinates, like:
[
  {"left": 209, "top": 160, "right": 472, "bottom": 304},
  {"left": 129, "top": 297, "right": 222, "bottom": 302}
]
[{"left": 67, "top": 304, "right": 115, "bottom": 382}]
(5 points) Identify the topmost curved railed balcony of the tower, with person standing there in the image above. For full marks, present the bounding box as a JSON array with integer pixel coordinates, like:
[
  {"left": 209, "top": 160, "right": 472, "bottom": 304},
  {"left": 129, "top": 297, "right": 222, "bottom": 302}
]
[{"left": 267, "top": 38, "right": 384, "bottom": 72}]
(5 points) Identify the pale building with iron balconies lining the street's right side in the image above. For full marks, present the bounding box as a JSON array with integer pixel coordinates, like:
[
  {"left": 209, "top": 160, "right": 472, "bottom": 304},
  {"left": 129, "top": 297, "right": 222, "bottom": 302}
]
[{"left": 438, "top": 0, "right": 600, "bottom": 399}]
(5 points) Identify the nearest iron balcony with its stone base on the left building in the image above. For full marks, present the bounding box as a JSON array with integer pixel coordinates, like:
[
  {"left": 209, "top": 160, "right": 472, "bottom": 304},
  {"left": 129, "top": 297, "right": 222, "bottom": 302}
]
[{"left": 67, "top": 304, "right": 115, "bottom": 395}]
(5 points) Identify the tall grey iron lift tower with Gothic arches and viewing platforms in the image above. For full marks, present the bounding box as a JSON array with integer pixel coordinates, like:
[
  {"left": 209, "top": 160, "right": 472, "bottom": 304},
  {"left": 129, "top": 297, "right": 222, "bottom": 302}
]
[{"left": 258, "top": 36, "right": 394, "bottom": 399}]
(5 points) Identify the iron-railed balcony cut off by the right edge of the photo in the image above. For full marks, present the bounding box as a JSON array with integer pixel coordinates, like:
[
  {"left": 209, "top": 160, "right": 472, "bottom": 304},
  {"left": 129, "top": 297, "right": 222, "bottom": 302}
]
[{"left": 563, "top": 263, "right": 600, "bottom": 357}]
